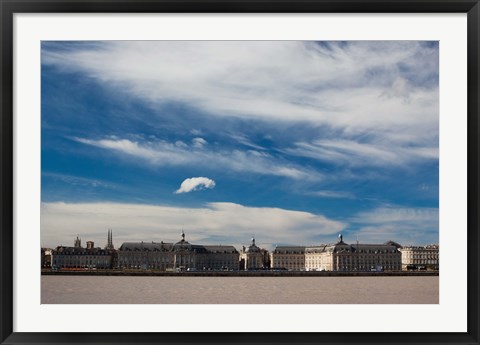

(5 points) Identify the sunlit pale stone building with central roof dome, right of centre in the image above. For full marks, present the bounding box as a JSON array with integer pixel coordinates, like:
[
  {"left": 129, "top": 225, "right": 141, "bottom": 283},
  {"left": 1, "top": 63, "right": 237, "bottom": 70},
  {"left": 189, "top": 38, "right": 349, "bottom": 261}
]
[{"left": 305, "top": 235, "right": 402, "bottom": 271}]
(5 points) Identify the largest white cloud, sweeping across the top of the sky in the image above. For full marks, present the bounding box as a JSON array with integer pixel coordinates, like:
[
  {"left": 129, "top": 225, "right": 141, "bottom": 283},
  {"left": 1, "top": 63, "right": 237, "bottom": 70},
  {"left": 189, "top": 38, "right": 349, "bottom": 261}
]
[{"left": 42, "top": 41, "right": 439, "bottom": 144}]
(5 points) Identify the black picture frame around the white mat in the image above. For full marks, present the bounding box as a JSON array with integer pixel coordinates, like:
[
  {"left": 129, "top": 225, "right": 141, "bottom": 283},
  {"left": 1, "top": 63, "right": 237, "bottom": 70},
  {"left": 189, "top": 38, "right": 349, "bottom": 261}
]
[{"left": 0, "top": 0, "right": 480, "bottom": 344}]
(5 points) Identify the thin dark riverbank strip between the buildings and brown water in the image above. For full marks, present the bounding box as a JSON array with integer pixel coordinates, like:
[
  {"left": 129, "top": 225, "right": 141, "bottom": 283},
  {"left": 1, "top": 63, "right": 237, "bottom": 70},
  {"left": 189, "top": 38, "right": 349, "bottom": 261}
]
[{"left": 42, "top": 270, "right": 439, "bottom": 277}]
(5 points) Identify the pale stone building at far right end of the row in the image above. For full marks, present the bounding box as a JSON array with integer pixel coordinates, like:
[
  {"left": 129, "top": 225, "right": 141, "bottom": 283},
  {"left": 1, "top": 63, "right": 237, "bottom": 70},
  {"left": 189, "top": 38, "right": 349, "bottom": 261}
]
[{"left": 400, "top": 244, "right": 440, "bottom": 271}]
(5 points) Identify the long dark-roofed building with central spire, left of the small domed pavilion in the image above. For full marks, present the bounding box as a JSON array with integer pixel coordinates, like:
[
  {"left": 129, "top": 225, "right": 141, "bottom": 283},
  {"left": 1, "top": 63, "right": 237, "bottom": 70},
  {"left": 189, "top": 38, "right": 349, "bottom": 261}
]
[{"left": 117, "top": 232, "right": 239, "bottom": 271}]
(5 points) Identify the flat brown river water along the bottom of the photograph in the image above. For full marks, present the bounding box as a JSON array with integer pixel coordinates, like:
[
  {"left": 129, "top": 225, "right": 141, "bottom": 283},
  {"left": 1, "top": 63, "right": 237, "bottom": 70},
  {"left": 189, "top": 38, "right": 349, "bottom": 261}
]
[{"left": 41, "top": 276, "right": 439, "bottom": 304}]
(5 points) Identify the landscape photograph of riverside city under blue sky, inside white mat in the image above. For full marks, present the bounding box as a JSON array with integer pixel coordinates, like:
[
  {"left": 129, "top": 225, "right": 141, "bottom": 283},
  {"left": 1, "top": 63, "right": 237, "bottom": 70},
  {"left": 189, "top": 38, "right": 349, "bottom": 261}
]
[{"left": 38, "top": 40, "right": 441, "bottom": 305}]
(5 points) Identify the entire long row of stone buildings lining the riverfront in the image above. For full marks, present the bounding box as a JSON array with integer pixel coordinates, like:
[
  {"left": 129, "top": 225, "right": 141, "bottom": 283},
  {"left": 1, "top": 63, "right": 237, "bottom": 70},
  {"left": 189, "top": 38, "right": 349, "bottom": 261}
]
[{"left": 41, "top": 230, "right": 439, "bottom": 272}]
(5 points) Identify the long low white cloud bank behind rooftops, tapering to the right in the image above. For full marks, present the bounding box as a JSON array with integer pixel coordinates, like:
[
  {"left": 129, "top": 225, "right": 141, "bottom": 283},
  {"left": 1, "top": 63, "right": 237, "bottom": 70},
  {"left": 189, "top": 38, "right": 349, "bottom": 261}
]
[{"left": 41, "top": 202, "right": 346, "bottom": 249}]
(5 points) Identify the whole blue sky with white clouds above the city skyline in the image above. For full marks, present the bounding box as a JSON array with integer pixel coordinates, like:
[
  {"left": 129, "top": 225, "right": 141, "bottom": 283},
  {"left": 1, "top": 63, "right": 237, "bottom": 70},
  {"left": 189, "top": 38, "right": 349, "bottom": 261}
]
[{"left": 41, "top": 41, "right": 439, "bottom": 248}]
